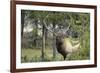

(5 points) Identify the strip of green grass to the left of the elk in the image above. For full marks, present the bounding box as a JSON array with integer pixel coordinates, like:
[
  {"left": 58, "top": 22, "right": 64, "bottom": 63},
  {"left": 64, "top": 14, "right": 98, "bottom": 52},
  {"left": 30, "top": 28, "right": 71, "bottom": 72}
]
[{"left": 21, "top": 49, "right": 63, "bottom": 63}]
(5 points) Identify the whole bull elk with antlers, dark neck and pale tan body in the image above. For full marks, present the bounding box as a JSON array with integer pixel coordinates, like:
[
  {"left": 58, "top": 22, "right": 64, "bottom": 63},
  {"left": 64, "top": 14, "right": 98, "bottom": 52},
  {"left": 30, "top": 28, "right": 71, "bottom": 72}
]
[{"left": 44, "top": 14, "right": 80, "bottom": 60}]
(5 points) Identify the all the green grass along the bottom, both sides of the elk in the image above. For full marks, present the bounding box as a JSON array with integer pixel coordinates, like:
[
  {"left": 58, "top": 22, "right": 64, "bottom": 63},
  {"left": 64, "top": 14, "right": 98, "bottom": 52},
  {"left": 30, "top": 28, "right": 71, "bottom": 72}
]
[{"left": 21, "top": 48, "right": 89, "bottom": 63}]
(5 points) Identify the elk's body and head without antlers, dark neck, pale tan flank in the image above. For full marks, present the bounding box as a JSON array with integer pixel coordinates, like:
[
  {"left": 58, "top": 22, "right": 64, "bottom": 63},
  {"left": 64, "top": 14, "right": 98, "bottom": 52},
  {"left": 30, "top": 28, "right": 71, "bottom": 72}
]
[{"left": 56, "top": 34, "right": 80, "bottom": 60}]
